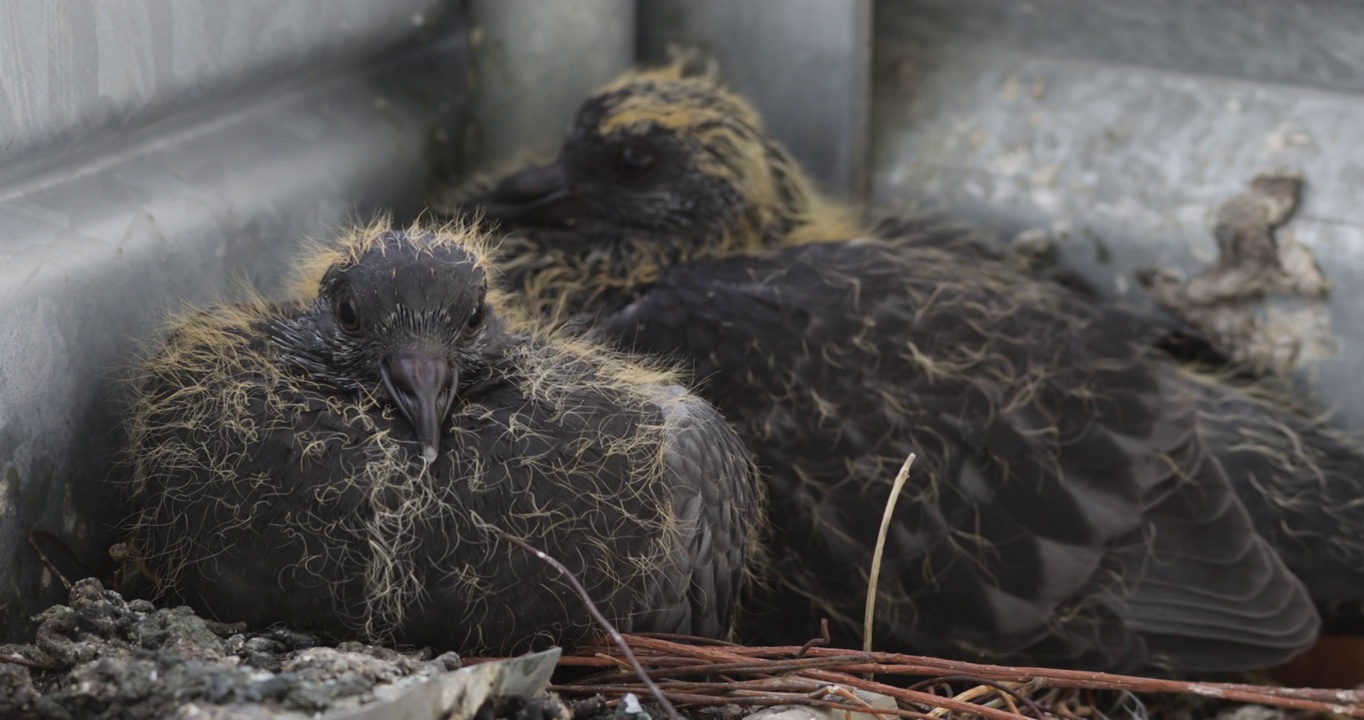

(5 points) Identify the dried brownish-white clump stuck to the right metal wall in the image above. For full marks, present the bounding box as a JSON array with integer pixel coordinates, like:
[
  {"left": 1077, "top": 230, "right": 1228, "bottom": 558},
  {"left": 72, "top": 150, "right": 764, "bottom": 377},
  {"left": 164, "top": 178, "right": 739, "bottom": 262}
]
[{"left": 1136, "top": 169, "right": 1334, "bottom": 376}]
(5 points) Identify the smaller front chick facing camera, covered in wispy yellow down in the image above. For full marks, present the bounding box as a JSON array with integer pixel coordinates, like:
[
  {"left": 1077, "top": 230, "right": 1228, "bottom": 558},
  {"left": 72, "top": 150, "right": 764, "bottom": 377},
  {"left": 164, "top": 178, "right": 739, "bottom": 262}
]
[{"left": 122, "top": 224, "right": 760, "bottom": 655}]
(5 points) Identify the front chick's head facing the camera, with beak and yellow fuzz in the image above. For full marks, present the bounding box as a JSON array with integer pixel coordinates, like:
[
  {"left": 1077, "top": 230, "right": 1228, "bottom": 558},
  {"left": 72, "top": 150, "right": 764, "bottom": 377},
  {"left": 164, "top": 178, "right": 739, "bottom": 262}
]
[{"left": 276, "top": 226, "right": 498, "bottom": 461}]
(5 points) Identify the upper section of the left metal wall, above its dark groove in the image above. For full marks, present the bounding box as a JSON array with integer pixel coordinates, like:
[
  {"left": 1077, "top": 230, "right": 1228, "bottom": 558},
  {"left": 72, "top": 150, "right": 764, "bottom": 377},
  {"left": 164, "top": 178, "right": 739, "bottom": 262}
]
[{"left": 0, "top": 0, "right": 450, "bottom": 181}]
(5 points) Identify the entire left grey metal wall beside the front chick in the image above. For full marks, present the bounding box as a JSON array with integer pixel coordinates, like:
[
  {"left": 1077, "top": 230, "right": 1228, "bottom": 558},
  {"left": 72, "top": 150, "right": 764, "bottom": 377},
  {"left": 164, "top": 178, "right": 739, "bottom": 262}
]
[{"left": 0, "top": 0, "right": 465, "bottom": 640}]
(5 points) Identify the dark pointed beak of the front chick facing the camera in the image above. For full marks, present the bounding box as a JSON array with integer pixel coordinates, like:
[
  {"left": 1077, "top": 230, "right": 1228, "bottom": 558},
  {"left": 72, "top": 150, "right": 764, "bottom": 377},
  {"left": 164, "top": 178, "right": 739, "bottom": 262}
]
[{"left": 379, "top": 350, "right": 460, "bottom": 462}]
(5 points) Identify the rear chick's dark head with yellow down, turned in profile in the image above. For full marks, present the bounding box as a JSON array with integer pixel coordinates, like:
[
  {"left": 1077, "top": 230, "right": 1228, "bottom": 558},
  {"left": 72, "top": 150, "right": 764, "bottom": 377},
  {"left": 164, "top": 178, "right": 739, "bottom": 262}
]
[{"left": 476, "top": 65, "right": 839, "bottom": 259}]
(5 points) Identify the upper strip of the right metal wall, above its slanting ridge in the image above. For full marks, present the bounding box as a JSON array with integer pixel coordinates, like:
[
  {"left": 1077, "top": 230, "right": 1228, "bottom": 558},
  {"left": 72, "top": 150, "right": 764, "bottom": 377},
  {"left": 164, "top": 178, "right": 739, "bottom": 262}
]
[{"left": 876, "top": 0, "right": 1364, "bottom": 93}]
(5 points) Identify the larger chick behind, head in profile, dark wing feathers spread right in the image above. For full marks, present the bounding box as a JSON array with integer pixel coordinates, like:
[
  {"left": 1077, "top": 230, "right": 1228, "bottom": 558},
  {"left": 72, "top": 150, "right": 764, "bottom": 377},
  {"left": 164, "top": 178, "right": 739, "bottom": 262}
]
[{"left": 439, "top": 64, "right": 1364, "bottom": 672}]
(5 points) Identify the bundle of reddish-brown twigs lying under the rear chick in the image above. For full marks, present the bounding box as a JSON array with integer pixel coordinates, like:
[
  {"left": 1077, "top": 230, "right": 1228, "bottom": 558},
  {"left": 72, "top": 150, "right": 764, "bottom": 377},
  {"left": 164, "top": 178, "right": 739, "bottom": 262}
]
[{"left": 463, "top": 634, "right": 1364, "bottom": 720}]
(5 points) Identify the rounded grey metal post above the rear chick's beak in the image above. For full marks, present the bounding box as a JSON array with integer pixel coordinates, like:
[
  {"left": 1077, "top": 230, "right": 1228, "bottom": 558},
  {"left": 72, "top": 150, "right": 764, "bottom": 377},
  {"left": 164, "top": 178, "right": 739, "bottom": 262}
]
[{"left": 461, "top": 0, "right": 636, "bottom": 168}]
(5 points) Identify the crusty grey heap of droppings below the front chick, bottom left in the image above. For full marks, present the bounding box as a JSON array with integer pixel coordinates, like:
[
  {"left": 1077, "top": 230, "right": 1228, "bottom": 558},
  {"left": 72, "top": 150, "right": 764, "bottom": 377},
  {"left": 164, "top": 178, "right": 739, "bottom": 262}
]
[{"left": 0, "top": 578, "right": 553, "bottom": 720}]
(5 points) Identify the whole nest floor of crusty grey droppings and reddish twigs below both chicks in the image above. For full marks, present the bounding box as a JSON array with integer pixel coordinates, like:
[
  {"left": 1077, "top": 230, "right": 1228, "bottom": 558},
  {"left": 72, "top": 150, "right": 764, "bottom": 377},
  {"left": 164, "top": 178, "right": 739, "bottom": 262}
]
[{"left": 0, "top": 533, "right": 1364, "bottom": 720}]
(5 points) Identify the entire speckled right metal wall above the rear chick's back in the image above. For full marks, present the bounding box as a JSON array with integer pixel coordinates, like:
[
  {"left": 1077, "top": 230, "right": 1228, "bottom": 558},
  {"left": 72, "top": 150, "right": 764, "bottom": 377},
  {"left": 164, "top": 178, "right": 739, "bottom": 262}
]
[{"left": 872, "top": 0, "right": 1364, "bottom": 427}]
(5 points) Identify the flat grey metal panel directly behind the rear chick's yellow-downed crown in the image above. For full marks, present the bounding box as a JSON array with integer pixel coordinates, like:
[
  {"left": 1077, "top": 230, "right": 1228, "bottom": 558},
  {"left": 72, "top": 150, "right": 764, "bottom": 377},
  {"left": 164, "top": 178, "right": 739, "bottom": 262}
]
[{"left": 640, "top": 0, "right": 872, "bottom": 196}]
